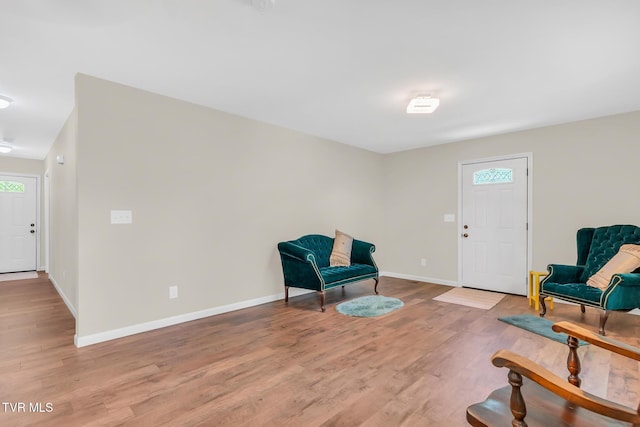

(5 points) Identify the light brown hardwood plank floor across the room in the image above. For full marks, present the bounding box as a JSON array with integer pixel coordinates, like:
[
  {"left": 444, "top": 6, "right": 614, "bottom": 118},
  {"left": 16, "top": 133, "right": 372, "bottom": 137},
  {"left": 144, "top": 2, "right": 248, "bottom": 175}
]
[{"left": 0, "top": 274, "right": 640, "bottom": 426}]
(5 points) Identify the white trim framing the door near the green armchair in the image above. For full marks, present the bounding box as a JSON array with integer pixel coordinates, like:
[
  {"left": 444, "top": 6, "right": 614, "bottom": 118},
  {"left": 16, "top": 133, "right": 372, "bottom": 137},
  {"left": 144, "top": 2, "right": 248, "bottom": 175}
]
[{"left": 457, "top": 152, "right": 533, "bottom": 287}]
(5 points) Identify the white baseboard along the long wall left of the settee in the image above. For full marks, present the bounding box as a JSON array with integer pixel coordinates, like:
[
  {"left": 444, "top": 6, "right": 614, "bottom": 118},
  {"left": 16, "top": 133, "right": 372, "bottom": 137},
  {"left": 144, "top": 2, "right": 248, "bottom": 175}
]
[{"left": 73, "top": 288, "right": 314, "bottom": 347}]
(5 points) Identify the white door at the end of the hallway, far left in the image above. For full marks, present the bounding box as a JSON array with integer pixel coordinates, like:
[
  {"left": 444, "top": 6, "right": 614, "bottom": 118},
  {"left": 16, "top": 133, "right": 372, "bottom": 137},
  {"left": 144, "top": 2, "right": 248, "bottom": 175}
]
[{"left": 0, "top": 175, "right": 38, "bottom": 273}]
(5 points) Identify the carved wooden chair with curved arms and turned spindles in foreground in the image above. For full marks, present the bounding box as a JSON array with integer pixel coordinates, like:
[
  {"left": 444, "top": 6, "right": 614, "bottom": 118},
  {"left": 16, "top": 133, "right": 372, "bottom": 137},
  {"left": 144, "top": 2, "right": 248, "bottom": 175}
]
[{"left": 467, "top": 322, "right": 640, "bottom": 427}]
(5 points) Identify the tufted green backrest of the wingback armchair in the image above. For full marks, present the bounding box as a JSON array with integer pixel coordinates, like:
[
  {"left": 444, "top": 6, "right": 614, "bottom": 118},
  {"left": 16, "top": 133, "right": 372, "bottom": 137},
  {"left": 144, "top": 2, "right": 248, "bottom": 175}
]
[{"left": 579, "top": 225, "right": 640, "bottom": 282}]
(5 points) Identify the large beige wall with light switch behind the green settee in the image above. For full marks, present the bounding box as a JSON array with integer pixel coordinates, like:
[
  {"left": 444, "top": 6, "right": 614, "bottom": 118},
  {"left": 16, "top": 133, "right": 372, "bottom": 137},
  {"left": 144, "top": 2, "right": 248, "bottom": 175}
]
[{"left": 75, "top": 75, "right": 382, "bottom": 338}]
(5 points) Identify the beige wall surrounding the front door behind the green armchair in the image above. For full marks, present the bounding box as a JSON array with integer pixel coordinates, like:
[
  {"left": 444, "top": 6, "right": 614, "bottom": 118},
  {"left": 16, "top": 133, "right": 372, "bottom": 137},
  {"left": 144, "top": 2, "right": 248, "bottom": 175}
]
[{"left": 379, "top": 112, "right": 640, "bottom": 282}]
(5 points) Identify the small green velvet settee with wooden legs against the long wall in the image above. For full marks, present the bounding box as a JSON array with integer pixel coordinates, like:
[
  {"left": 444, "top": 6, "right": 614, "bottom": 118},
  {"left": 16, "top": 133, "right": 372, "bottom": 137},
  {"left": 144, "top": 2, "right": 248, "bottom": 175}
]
[{"left": 278, "top": 234, "right": 378, "bottom": 311}]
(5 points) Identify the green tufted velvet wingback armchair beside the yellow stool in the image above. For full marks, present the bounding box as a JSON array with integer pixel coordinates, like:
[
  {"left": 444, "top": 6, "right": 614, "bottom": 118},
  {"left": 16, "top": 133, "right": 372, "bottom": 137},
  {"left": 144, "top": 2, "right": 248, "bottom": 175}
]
[{"left": 540, "top": 225, "right": 640, "bottom": 335}]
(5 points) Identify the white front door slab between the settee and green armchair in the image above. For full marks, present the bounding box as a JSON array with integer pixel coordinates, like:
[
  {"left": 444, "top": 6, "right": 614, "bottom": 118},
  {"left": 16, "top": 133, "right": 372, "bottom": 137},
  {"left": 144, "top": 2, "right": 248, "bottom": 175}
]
[{"left": 460, "top": 157, "right": 528, "bottom": 295}]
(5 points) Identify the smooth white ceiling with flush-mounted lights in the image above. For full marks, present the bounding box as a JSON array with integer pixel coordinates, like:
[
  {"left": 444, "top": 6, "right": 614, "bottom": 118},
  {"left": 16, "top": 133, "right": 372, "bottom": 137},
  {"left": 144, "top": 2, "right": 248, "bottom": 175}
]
[{"left": 0, "top": 0, "right": 640, "bottom": 159}]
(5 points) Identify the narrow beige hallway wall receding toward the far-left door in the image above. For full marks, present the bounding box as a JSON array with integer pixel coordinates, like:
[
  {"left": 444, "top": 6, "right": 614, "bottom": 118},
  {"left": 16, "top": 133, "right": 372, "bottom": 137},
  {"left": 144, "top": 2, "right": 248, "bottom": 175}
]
[{"left": 44, "top": 110, "right": 78, "bottom": 322}]
